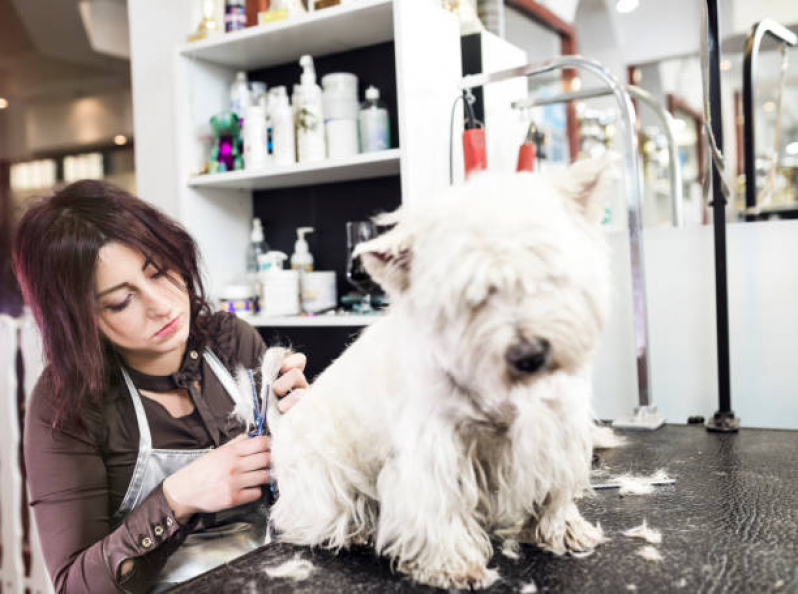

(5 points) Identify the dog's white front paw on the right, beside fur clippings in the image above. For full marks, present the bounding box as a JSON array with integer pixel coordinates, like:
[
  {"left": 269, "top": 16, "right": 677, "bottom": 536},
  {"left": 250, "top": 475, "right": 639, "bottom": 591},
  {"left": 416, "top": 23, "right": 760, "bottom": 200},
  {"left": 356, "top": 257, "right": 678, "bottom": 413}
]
[{"left": 525, "top": 496, "right": 605, "bottom": 555}]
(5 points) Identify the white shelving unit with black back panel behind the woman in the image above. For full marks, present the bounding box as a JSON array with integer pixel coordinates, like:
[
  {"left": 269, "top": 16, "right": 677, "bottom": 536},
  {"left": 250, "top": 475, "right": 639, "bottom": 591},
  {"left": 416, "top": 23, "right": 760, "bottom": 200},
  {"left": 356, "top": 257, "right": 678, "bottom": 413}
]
[{"left": 169, "top": 0, "right": 462, "bottom": 328}]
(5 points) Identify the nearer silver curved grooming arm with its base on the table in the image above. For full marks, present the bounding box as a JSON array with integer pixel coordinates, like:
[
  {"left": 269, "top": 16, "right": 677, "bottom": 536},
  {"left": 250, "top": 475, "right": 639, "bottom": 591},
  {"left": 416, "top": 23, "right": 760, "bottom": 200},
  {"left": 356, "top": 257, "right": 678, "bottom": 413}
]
[{"left": 461, "top": 56, "right": 665, "bottom": 429}]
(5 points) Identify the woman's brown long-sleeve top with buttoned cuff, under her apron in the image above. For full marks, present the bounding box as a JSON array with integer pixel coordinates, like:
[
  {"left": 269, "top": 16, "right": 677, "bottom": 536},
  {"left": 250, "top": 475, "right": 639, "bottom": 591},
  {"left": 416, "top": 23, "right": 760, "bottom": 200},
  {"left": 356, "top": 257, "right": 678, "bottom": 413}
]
[{"left": 24, "top": 313, "right": 265, "bottom": 593}]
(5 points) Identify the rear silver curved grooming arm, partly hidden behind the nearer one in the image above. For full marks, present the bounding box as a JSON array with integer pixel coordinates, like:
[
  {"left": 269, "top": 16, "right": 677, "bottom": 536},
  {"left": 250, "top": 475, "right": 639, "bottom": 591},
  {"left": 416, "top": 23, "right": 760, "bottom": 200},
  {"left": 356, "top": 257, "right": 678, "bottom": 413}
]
[{"left": 513, "top": 85, "right": 684, "bottom": 227}]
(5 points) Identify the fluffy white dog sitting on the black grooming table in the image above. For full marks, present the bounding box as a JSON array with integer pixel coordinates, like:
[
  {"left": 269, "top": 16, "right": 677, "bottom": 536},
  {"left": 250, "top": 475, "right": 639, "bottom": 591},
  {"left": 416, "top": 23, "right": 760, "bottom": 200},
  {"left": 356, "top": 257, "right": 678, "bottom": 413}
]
[{"left": 264, "top": 161, "right": 610, "bottom": 588}]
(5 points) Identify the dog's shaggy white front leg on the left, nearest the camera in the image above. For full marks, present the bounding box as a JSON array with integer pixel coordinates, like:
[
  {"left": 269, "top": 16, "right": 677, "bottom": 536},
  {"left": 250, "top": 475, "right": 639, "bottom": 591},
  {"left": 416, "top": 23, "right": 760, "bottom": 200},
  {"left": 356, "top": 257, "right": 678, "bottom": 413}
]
[{"left": 376, "top": 432, "right": 498, "bottom": 589}]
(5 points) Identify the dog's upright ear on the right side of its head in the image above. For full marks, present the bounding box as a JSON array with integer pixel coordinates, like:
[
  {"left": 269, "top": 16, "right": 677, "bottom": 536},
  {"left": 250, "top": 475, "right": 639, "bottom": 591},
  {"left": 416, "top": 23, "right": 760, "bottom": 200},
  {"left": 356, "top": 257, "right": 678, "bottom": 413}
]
[{"left": 544, "top": 153, "right": 619, "bottom": 224}]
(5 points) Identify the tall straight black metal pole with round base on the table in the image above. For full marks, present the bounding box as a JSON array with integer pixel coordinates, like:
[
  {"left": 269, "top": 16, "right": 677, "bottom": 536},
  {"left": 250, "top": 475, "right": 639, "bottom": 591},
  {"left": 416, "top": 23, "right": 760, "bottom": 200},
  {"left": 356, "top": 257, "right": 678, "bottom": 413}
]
[{"left": 703, "top": 0, "right": 740, "bottom": 432}]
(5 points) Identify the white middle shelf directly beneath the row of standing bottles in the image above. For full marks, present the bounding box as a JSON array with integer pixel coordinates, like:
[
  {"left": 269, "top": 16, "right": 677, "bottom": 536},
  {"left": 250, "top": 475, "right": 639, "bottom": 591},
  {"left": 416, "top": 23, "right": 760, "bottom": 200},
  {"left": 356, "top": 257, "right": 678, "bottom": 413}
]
[{"left": 188, "top": 149, "right": 400, "bottom": 190}]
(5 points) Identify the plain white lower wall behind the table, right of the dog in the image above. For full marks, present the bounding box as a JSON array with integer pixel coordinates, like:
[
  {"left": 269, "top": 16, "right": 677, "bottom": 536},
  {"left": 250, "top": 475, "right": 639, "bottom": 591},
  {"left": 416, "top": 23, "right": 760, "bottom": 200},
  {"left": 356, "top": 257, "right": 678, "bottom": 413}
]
[{"left": 594, "top": 221, "right": 798, "bottom": 429}]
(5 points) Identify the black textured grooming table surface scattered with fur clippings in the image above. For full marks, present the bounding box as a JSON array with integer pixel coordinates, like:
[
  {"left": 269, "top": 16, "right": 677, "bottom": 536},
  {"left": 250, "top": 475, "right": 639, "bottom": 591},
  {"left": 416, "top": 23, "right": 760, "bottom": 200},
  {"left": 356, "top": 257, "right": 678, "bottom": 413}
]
[{"left": 171, "top": 426, "right": 798, "bottom": 594}]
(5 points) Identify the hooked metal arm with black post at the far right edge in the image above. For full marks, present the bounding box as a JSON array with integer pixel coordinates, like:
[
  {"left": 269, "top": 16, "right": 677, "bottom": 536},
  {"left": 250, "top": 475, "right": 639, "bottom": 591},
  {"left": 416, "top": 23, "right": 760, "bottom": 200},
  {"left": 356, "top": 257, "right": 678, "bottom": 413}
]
[{"left": 743, "top": 19, "right": 798, "bottom": 220}]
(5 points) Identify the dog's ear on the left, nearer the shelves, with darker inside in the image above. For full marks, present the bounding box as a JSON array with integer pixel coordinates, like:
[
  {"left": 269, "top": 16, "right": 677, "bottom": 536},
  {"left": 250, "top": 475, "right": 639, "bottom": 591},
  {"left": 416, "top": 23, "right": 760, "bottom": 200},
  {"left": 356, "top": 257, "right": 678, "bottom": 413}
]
[{"left": 354, "top": 219, "right": 412, "bottom": 295}]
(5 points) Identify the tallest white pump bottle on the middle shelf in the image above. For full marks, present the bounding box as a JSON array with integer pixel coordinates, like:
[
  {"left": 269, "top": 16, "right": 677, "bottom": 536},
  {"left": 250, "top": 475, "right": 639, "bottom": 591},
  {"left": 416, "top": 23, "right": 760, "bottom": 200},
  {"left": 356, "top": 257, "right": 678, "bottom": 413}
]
[{"left": 294, "top": 54, "right": 326, "bottom": 163}]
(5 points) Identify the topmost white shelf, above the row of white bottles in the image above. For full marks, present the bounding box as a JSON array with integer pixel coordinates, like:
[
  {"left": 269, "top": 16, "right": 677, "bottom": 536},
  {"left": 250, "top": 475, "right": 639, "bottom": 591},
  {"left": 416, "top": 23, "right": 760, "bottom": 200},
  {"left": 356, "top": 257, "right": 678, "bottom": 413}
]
[{"left": 180, "top": 0, "right": 393, "bottom": 70}]
